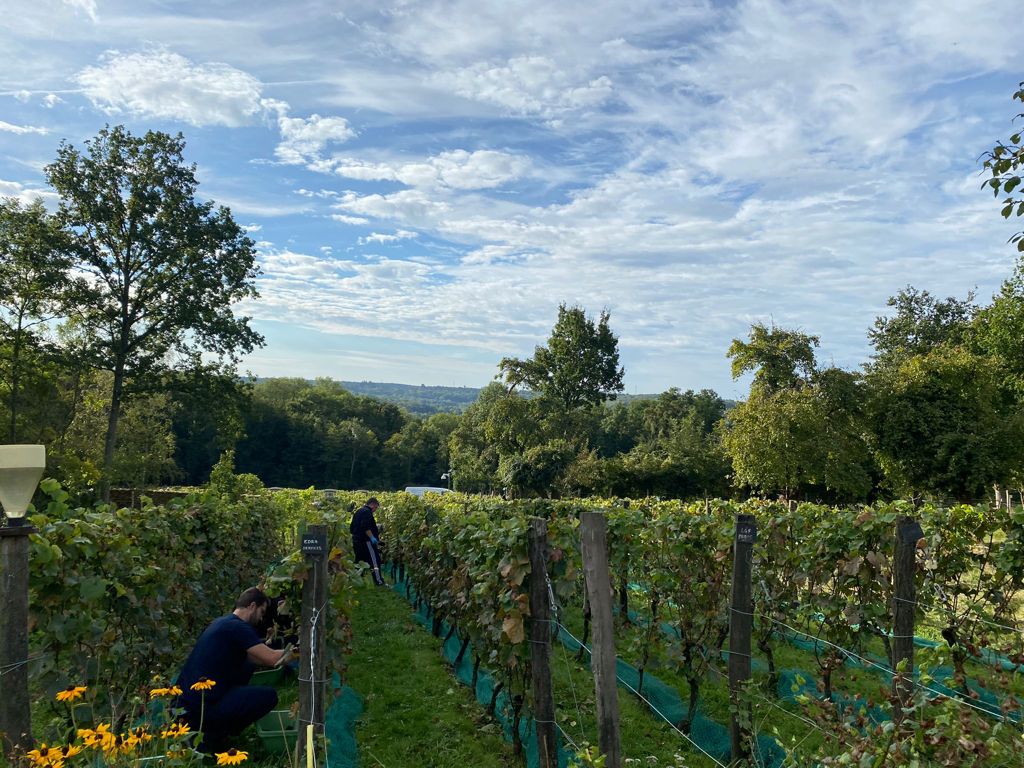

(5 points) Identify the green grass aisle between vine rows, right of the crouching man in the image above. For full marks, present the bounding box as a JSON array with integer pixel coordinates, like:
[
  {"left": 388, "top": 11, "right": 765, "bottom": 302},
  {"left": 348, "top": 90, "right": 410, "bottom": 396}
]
[{"left": 348, "top": 586, "right": 519, "bottom": 768}]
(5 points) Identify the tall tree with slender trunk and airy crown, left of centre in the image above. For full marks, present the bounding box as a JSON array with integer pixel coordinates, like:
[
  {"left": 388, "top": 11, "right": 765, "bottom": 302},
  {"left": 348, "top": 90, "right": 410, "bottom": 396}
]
[{"left": 46, "top": 126, "right": 263, "bottom": 498}]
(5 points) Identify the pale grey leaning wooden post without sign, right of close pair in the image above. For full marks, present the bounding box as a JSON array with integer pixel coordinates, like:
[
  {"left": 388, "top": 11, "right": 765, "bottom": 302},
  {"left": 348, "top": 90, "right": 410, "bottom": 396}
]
[{"left": 580, "top": 512, "right": 623, "bottom": 768}]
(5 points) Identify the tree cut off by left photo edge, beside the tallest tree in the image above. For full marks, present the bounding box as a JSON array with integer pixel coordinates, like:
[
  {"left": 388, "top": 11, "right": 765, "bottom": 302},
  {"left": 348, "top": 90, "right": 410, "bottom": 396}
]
[{"left": 0, "top": 198, "right": 71, "bottom": 442}]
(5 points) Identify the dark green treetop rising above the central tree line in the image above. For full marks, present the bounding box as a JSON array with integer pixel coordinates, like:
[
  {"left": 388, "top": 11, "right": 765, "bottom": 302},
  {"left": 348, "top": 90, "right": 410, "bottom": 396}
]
[{"left": 499, "top": 304, "right": 625, "bottom": 411}]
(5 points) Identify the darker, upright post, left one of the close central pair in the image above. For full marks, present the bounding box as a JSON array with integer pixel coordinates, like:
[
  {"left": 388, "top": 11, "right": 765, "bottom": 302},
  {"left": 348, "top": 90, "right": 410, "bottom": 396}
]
[{"left": 529, "top": 517, "right": 558, "bottom": 768}]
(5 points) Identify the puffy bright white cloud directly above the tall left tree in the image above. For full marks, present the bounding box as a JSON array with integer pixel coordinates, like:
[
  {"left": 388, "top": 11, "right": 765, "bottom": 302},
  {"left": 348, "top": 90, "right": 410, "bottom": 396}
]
[{"left": 75, "top": 49, "right": 265, "bottom": 127}]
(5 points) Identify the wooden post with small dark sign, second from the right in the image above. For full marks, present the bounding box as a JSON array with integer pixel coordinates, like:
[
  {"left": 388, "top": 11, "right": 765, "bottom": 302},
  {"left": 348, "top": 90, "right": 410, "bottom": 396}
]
[{"left": 729, "top": 515, "right": 758, "bottom": 765}]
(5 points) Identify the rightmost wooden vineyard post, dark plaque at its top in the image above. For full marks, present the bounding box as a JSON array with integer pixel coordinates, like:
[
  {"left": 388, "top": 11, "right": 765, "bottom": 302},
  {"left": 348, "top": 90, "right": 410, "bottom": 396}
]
[{"left": 892, "top": 517, "right": 924, "bottom": 723}]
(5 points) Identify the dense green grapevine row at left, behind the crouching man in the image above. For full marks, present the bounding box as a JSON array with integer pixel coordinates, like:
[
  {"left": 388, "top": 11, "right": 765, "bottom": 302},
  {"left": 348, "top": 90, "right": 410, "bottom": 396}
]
[{"left": 29, "top": 480, "right": 284, "bottom": 720}]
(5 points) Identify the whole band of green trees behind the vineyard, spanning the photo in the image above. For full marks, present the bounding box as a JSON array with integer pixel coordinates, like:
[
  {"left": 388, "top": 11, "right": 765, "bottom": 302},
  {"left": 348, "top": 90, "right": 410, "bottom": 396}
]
[{"left": 6, "top": 84, "right": 1024, "bottom": 502}]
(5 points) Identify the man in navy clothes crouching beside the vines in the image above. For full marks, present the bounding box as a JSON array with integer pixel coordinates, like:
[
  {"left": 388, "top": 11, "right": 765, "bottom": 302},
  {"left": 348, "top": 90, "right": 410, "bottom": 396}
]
[{"left": 177, "top": 587, "right": 289, "bottom": 752}]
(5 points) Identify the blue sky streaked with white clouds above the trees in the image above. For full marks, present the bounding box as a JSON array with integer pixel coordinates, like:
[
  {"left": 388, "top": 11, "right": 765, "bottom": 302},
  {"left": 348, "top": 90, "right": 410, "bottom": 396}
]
[{"left": 0, "top": 0, "right": 1024, "bottom": 396}]
